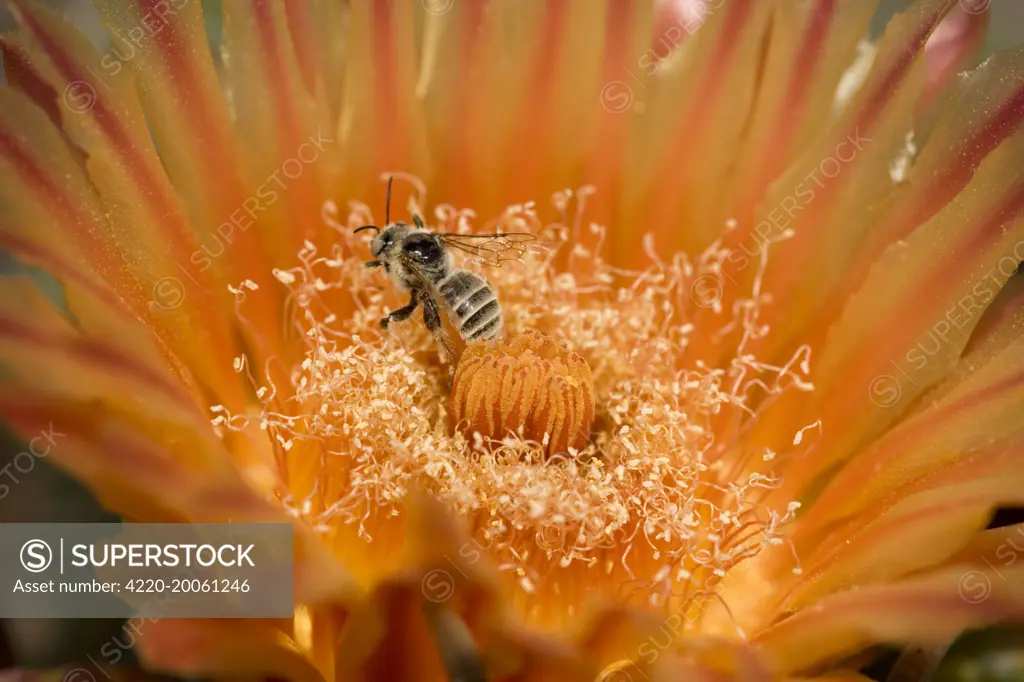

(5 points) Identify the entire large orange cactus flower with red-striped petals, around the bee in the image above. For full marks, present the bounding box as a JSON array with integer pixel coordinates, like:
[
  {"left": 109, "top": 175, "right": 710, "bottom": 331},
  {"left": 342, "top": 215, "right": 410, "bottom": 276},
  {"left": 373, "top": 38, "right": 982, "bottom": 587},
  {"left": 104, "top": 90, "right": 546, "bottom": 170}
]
[{"left": 0, "top": 0, "right": 1024, "bottom": 682}]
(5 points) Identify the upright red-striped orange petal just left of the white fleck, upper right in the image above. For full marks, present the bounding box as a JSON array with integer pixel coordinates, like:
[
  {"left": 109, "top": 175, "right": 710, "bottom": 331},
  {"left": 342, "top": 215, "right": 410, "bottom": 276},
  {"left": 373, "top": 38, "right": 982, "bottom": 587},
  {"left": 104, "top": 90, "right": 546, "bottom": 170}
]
[{"left": 687, "top": 0, "right": 877, "bottom": 363}]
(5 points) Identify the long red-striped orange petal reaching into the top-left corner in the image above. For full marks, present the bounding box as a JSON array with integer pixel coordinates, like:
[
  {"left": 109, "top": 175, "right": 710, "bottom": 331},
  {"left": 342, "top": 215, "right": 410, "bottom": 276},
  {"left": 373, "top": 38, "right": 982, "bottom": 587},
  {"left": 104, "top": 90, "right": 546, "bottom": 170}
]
[{"left": 0, "top": 0, "right": 247, "bottom": 404}]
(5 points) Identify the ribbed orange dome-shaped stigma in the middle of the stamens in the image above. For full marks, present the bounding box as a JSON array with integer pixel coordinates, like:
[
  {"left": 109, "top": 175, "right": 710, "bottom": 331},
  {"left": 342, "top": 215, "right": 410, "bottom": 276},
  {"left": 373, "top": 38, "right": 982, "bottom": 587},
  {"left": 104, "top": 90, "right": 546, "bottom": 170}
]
[{"left": 450, "top": 331, "right": 594, "bottom": 456}]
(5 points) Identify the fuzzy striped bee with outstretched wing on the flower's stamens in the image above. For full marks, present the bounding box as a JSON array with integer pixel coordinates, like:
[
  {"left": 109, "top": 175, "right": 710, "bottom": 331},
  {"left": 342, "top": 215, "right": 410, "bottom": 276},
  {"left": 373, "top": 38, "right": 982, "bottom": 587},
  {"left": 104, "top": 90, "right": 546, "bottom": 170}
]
[{"left": 355, "top": 178, "right": 536, "bottom": 357}]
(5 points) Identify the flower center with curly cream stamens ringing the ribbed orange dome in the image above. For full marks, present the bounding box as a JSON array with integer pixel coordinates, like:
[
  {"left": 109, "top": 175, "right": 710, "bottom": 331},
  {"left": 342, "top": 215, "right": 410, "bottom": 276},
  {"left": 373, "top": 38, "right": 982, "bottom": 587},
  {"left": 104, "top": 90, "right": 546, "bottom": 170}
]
[{"left": 218, "top": 188, "right": 804, "bottom": 627}]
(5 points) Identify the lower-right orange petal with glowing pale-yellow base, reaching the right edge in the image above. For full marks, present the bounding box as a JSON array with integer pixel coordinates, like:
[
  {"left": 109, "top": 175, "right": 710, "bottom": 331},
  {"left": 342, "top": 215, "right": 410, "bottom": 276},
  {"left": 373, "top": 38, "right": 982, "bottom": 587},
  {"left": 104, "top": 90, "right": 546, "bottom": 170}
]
[{"left": 729, "top": 443, "right": 1024, "bottom": 631}]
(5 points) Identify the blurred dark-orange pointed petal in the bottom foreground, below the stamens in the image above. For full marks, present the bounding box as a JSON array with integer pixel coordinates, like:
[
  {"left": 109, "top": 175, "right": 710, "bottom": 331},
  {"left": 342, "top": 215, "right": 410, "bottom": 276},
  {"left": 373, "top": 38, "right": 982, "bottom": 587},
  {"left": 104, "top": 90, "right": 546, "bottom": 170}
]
[{"left": 336, "top": 496, "right": 607, "bottom": 682}]
